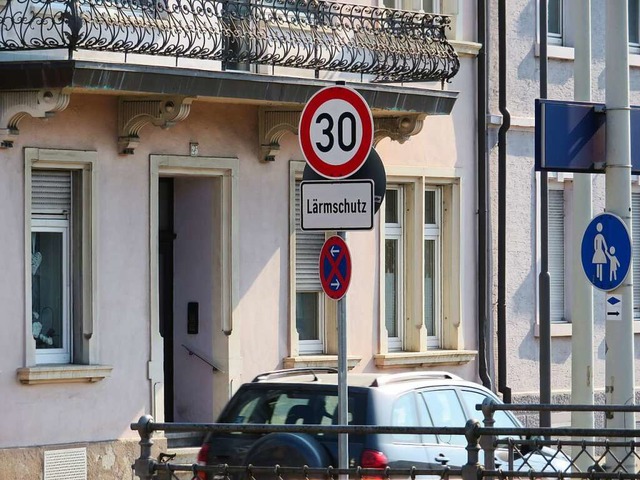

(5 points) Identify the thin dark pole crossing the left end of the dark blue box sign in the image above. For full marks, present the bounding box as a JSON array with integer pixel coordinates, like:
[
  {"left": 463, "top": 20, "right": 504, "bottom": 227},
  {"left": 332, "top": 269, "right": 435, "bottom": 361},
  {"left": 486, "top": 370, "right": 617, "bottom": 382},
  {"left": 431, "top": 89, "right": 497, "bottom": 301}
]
[{"left": 538, "top": 0, "right": 551, "bottom": 427}]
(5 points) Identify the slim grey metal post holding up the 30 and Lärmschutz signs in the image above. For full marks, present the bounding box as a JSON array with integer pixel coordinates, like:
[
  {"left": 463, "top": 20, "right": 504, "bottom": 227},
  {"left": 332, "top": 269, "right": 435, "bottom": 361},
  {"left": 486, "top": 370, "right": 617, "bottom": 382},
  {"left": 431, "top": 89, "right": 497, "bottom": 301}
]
[{"left": 338, "top": 232, "right": 349, "bottom": 480}]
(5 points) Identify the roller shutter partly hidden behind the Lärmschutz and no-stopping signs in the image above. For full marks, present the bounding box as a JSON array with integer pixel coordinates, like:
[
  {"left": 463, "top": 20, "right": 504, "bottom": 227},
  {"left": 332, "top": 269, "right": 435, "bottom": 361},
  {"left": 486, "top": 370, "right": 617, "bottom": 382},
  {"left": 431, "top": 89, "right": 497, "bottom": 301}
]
[{"left": 295, "top": 182, "right": 325, "bottom": 292}]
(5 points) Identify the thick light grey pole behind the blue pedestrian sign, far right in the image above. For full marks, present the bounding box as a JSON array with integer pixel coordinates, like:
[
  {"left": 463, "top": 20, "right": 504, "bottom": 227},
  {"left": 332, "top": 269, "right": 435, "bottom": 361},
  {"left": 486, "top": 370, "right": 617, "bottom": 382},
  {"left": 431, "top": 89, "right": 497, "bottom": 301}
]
[{"left": 605, "top": 0, "right": 635, "bottom": 471}]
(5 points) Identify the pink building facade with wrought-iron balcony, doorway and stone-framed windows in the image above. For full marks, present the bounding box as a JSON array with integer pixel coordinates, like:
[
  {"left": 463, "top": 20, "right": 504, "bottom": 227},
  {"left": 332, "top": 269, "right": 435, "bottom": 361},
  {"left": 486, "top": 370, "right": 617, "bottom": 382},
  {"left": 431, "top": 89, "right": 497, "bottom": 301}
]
[{"left": 0, "top": 0, "right": 480, "bottom": 479}]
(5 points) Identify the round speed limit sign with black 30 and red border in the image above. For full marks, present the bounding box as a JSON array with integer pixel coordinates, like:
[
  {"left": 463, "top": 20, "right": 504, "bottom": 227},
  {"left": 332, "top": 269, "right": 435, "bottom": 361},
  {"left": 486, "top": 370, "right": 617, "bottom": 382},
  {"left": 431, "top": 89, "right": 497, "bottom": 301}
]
[{"left": 298, "top": 86, "right": 373, "bottom": 179}]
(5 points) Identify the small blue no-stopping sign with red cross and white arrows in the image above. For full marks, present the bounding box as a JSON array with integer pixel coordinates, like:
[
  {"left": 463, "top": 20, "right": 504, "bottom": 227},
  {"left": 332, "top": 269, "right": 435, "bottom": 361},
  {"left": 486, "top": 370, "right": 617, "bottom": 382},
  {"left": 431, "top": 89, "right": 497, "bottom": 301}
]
[{"left": 319, "top": 235, "right": 351, "bottom": 300}]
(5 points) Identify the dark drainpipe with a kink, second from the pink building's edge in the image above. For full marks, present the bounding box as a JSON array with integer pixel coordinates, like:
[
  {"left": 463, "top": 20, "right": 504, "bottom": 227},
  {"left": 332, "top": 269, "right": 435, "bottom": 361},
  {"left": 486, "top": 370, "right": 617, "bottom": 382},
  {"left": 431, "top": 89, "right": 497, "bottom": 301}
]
[{"left": 497, "top": 0, "right": 511, "bottom": 403}]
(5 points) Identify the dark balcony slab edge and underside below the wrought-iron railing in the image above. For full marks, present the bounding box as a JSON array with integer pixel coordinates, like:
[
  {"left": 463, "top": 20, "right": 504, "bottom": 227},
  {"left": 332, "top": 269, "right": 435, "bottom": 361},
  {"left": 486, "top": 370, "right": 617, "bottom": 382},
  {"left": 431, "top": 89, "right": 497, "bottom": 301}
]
[{"left": 0, "top": 60, "right": 458, "bottom": 117}]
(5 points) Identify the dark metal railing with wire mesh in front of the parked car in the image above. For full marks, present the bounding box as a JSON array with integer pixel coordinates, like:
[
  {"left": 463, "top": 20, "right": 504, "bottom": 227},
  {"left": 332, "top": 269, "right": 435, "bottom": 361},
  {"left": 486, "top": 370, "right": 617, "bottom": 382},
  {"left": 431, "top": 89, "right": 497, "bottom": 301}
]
[{"left": 131, "top": 402, "right": 640, "bottom": 480}]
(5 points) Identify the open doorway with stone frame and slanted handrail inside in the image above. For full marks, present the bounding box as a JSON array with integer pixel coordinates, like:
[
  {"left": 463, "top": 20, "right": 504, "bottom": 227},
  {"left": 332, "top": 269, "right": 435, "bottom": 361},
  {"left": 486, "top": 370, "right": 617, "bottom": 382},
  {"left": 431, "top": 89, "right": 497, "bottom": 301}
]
[{"left": 149, "top": 155, "right": 241, "bottom": 422}]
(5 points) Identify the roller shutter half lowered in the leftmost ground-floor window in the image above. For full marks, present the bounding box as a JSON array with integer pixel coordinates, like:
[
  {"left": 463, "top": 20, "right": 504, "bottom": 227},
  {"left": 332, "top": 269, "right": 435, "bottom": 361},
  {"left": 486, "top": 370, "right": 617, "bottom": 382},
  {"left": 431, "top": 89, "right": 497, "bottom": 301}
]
[{"left": 31, "top": 170, "right": 71, "bottom": 215}]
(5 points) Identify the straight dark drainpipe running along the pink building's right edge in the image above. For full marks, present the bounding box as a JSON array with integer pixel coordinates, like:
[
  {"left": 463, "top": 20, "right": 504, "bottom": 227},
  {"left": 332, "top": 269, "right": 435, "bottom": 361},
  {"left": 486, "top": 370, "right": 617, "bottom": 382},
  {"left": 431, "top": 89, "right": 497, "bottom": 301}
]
[{"left": 476, "top": 0, "right": 493, "bottom": 390}]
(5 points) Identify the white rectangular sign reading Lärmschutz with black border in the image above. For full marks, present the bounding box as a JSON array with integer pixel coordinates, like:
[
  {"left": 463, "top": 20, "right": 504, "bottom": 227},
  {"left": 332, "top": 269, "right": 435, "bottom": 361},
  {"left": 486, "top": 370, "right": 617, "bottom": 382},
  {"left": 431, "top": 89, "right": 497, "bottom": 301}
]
[{"left": 300, "top": 180, "right": 374, "bottom": 230}]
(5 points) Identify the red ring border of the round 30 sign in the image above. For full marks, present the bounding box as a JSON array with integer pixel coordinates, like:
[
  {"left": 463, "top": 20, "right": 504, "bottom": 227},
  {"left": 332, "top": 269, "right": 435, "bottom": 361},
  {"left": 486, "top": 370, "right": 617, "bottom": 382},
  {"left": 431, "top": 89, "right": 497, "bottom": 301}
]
[{"left": 298, "top": 85, "right": 373, "bottom": 180}]
